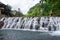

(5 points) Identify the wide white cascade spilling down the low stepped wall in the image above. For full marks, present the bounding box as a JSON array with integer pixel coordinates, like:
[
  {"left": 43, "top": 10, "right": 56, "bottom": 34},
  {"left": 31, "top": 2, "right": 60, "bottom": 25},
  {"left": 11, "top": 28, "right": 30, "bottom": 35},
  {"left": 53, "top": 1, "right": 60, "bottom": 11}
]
[{"left": 0, "top": 17, "right": 60, "bottom": 31}]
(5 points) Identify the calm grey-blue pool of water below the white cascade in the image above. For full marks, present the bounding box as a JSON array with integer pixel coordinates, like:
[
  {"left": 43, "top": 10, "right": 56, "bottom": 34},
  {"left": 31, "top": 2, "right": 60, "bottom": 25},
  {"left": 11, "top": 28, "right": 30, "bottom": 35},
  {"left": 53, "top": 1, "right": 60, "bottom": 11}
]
[{"left": 0, "top": 30, "right": 60, "bottom": 40}]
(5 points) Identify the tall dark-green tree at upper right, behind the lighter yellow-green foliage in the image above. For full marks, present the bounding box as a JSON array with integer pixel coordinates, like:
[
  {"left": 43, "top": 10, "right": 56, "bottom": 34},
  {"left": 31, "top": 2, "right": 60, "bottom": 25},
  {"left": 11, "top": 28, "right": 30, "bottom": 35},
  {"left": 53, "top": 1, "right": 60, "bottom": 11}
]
[{"left": 40, "top": 0, "right": 60, "bottom": 15}]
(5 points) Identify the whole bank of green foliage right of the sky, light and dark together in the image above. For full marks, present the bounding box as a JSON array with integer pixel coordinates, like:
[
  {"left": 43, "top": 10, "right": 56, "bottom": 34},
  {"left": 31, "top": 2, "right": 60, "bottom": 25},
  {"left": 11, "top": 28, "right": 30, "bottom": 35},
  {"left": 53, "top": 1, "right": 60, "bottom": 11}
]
[{"left": 26, "top": 0, "right": 60, "bottom": 16}]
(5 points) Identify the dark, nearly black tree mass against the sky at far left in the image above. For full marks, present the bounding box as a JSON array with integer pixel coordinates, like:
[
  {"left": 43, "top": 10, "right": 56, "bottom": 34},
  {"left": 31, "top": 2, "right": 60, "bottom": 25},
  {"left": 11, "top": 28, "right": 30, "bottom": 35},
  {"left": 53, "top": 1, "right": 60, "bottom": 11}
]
[{"left": 0, "top": 2, "right": 12, "bottom": 16}]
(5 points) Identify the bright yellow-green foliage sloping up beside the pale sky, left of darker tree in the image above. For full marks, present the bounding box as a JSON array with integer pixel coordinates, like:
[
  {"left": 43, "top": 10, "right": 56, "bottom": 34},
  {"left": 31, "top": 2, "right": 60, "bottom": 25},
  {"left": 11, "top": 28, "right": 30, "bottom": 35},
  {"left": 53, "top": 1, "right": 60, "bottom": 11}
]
[{"left": 28, "top": 3, "right": 41, "bottom": 16}]
